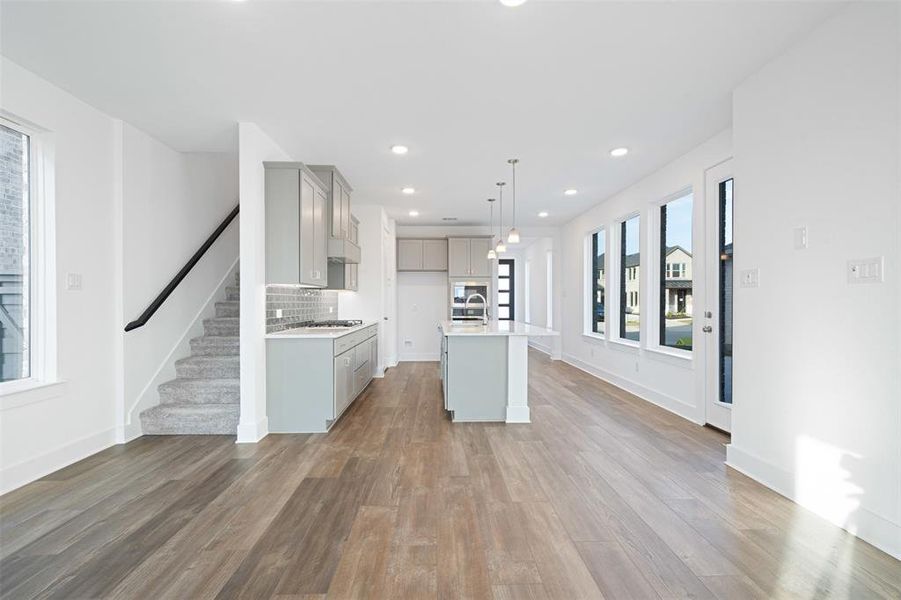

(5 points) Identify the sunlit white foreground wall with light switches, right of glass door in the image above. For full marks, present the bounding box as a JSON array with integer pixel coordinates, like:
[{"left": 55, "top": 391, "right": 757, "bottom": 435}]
[{"left": 728, "top": 3, "right": 901, "bottom": 556}]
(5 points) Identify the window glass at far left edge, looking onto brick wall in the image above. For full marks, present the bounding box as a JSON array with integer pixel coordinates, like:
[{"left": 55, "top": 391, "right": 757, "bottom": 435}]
[{"left": 0, "top": 124, "right": 32, "bottom": 382}]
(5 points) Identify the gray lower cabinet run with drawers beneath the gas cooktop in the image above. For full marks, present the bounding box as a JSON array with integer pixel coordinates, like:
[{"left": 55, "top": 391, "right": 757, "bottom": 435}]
[{"left": 266, "top": 325, "right": 378, "bottom": 433}]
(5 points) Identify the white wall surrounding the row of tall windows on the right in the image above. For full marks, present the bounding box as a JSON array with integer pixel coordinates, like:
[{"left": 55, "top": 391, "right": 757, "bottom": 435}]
[{"left": 560, "top": 130, "right": 732, "bottom": 423}]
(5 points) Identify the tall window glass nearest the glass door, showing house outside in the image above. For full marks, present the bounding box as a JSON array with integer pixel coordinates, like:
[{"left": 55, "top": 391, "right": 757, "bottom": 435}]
[{"left": 660, "top": 193, "right": 693, "bottom": 350}]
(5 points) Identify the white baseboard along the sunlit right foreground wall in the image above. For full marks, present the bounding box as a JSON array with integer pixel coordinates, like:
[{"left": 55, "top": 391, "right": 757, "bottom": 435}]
[{"left": 726, "top": 444, "right": 901, "bottom": 559}]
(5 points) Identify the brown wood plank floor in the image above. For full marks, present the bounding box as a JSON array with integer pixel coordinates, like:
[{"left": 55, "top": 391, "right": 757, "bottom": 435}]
[{"left": 0, "top": 352, "right": 901, "bottom": 600}]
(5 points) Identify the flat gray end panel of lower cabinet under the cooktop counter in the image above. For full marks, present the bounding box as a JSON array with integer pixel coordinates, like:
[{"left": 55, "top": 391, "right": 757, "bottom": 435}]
[{"left": 266, "top": 338, "right": 335, "bottom": 433}]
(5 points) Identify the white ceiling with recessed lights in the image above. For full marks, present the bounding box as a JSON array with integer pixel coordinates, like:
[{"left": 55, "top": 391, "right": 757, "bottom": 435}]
[{"left": 0, "top": 0, "right": 837, "bottom": 225}]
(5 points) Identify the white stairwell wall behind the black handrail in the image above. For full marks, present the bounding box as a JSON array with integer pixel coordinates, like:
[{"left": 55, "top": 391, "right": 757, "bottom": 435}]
[{"left": 122, "top": 123, "right": 238, "bottom": 439}]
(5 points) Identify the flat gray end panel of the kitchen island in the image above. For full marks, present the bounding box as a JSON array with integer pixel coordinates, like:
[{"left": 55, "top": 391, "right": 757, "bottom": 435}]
[{"left": 447, "top": 335, "right": 507, "bottom": 422}]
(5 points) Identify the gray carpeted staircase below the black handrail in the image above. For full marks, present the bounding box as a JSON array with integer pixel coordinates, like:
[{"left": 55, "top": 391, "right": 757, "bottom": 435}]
[{"left": 141, "top": 274, "right": 241, "bottom": 435}]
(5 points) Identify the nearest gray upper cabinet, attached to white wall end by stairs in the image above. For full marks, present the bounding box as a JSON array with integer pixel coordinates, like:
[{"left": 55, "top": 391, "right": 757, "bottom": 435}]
[{"left": 263, "top": 162, "right": 328, "bottom": 287}]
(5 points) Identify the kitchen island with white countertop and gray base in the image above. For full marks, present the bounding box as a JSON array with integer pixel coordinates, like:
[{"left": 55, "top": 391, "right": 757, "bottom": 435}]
[{"left": 438, "top": 321, "right": 559, "bottom": 423}]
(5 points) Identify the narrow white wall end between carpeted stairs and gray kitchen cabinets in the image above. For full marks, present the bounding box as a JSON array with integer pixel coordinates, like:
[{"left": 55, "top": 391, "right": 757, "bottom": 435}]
[{"left": 238, "top": 123, "right": 291, "bottom": 443}]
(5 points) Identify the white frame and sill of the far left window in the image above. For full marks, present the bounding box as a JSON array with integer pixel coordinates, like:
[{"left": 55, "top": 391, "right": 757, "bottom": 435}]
[{"left": 0, "top": 115, "right": 60, "bottom": 400}]
